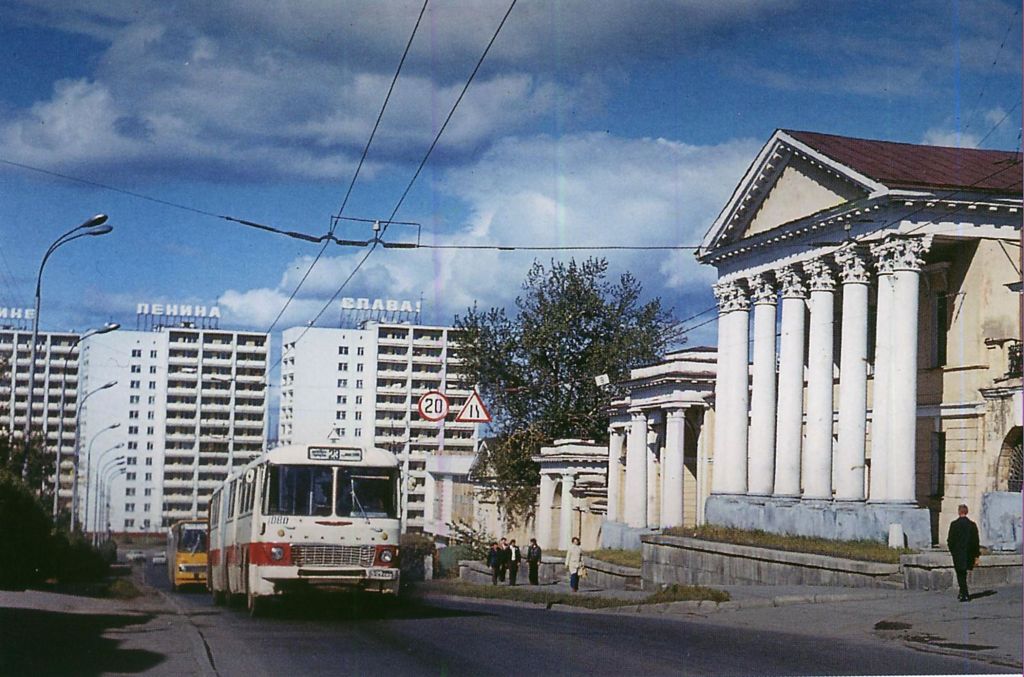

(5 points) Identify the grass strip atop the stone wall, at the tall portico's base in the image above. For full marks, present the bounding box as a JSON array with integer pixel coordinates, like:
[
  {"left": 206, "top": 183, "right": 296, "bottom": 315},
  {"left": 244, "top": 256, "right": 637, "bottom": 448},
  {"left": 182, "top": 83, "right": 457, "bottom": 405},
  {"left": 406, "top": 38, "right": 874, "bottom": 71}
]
[{"left": 666, "top": 525, "right": 918, "bottom": 564}]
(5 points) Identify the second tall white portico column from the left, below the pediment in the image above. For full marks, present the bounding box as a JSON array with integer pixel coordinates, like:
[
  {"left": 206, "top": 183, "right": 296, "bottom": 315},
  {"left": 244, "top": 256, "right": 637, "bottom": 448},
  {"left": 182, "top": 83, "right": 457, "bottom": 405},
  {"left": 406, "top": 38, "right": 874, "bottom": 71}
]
[{"left": 746, "top": 274, "right": 777, "bottom": 496}]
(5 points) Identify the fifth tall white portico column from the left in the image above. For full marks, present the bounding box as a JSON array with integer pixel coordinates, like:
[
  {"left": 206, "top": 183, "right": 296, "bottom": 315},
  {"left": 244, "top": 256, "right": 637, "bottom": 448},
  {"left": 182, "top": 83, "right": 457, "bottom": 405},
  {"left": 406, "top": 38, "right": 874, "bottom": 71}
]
[{"left": 836, "top": 248, "right": 870, "bottom": 501}]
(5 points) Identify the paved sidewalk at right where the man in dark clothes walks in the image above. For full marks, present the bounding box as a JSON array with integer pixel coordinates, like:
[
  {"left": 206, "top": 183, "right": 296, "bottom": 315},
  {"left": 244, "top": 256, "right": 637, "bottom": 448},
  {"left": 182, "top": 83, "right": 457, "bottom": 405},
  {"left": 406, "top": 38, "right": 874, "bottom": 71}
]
[{"left": 423, "top": 583, "right": 1024, "bottom": 673}]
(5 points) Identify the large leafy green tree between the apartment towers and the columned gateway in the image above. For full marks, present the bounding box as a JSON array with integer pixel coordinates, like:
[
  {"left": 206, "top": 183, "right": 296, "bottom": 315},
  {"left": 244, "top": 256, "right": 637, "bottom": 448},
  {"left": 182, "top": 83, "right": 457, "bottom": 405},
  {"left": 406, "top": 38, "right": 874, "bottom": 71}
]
[{"left": 455, "top": 258, "right": 682, "bottom": 522}]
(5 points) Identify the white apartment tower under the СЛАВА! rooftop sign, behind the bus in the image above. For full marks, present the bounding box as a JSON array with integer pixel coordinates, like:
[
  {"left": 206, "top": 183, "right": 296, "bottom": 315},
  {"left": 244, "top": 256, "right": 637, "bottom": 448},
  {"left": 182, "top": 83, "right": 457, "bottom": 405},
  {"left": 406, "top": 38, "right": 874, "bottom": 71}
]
[{"left": 279, "top": 322, "right": 476, "bottom": 533}]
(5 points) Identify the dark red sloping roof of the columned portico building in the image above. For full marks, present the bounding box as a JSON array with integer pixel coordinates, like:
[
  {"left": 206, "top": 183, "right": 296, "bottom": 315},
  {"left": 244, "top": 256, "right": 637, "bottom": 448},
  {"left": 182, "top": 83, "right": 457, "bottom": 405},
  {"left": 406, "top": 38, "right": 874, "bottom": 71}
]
[{"left": 782, "top": 130, "right": 1022, "bottom": 196}]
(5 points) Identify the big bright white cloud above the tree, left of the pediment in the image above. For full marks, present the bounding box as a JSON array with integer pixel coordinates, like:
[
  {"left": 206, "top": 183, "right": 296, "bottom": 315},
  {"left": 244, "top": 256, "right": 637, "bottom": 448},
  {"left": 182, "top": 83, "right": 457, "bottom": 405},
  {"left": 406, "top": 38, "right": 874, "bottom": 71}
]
[{"left": 220, "top": 133, "right": 760, "bottom": 328}]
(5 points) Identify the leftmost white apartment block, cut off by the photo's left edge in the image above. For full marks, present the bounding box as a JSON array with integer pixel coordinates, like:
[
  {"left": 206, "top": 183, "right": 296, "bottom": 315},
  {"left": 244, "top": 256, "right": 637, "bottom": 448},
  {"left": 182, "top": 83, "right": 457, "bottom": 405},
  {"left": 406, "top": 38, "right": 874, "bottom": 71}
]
[{"left": 0, "top": 323, "right": 79, "bottom": 508}]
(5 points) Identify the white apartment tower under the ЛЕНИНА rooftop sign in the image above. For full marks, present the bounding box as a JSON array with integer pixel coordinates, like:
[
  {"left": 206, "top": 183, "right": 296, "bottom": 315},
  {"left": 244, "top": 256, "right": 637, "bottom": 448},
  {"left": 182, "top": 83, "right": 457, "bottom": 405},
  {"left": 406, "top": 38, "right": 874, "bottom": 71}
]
[{"left": 79, "top": 322, "right": 269, "bottom": 532}]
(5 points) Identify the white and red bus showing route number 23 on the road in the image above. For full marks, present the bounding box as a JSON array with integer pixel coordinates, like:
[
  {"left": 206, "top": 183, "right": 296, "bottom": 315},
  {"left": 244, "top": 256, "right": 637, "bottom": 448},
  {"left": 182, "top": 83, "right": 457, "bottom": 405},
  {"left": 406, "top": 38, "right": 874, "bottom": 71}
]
[{"left": 207, "top": 445, "right": 399, "bottom": 615}]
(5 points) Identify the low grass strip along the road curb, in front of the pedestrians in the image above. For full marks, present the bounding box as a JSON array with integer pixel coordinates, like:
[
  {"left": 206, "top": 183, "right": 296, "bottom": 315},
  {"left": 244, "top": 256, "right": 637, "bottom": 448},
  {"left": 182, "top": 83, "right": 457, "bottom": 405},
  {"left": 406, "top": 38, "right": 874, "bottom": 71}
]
[{"left": 429, "top": 581, "right": 729, "bottom": 608}]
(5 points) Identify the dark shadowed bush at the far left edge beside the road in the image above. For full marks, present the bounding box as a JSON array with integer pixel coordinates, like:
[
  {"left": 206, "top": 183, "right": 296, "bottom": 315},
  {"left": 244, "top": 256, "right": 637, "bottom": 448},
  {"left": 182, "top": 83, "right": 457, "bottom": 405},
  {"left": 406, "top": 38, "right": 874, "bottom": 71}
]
[{"left": 0, "top": 471, "right": 53, "bottom": 589}]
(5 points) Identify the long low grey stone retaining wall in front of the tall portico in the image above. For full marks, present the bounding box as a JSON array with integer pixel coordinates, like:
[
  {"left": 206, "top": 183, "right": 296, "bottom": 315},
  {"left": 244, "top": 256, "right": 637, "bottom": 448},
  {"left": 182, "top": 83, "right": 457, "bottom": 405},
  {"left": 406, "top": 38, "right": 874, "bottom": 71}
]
[{"left": 642, "top": 536, "right": 903, "bottom": 590}]
